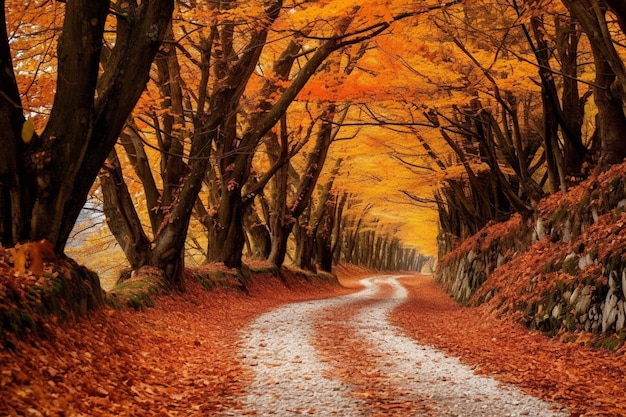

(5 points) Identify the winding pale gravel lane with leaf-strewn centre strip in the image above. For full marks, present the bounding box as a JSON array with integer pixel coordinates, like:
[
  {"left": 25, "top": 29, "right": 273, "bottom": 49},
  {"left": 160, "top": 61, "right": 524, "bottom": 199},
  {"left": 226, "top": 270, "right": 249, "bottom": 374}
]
[{"left": 224, "top": 276, "right": 569, "bottom": 416}]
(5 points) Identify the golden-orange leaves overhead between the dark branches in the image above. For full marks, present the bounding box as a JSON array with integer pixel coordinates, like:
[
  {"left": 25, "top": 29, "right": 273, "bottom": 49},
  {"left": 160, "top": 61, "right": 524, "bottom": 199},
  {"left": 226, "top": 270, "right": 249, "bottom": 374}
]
[{"left": 6, "top": 0, "right": 568, "bottom": 256}]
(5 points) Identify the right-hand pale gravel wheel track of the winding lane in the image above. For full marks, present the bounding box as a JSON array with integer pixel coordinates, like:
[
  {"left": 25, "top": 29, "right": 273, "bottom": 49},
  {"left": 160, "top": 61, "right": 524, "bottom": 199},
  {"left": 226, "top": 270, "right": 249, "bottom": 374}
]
[{"left": 351, "top": 277, "right": 569, "bottom": 417}]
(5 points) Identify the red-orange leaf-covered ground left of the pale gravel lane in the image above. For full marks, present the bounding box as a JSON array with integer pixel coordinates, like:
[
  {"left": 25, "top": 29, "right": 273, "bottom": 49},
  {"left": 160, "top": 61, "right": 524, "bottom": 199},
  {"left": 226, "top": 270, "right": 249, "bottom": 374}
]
[{"left": 0, "top": 274, "right": 350, "bottom": 417}]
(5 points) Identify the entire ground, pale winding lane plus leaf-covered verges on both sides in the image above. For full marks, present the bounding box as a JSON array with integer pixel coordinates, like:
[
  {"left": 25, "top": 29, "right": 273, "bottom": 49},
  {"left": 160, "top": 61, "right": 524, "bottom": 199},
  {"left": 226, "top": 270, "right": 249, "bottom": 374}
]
[{"left": 0, "top": 270, "right": 626, "bottom": 417}]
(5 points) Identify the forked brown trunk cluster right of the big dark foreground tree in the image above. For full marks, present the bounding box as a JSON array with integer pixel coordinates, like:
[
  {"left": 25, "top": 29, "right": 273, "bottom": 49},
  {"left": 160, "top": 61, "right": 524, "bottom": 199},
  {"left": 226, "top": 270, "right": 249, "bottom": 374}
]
[{"left": 101, "top": 17, "right": 210, "bottom": 291}]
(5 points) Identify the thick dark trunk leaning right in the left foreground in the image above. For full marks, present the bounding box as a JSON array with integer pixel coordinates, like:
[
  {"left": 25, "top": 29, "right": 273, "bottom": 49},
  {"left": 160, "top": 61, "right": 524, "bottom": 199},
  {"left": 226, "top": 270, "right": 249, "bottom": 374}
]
[{"left": 44, "top": 0, "right": 173, "bottom": 250}]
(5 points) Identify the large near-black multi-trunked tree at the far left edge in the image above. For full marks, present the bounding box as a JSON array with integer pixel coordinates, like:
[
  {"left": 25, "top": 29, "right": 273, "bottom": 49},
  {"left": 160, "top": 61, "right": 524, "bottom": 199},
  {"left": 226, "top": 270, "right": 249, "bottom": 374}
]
[{"left": 0, "top": 0, "right": 173, "bottom": 252}]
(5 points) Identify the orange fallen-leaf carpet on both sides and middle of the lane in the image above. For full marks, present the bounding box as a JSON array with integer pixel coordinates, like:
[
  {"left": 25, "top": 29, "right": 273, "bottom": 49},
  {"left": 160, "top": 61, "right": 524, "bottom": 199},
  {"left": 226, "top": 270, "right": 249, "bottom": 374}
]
[{"left": 0, "top": 269, "right": 626, "bottom": 416}]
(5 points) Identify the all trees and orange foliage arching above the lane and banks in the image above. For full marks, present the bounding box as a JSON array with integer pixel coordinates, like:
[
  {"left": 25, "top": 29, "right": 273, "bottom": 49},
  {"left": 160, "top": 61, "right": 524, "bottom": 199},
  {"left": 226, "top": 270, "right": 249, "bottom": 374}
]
[{"left": 0, "top": 0, "right": 626, "bottom": 288}]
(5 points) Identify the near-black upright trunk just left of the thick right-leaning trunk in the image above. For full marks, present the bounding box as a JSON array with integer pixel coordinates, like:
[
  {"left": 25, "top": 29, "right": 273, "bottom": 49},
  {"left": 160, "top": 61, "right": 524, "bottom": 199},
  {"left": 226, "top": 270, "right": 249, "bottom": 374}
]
[{"left": 31, "top": 0, "right": 109, "bottom": 252}]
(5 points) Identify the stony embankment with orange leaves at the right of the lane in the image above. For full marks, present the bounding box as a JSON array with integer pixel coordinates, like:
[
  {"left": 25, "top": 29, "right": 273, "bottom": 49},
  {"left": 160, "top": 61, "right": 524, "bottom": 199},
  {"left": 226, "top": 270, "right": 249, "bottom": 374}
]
[{"left": 436, "top": 164, "right": 626, "bottom": 349}]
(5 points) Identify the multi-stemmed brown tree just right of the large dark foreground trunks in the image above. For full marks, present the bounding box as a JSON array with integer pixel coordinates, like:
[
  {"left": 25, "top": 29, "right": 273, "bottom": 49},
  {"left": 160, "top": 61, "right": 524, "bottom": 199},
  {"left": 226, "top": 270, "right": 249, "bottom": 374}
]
[{"left": 101, "top": 1, "right": 282, "bottom": 289}]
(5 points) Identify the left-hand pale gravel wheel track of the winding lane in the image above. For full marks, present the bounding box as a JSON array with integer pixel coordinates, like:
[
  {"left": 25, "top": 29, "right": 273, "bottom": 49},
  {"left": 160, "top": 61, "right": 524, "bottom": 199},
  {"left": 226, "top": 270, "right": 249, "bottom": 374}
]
[{"left": 226, "top": 297, "right": 360, "bottom": 416}]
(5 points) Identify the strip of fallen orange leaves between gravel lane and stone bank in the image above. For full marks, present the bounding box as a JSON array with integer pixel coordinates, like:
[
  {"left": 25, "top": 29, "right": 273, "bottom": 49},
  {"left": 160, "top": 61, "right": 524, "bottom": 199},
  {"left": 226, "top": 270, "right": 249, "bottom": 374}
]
[{"left": 391, "top": 278, "right": 626, "bottom": 417}]
